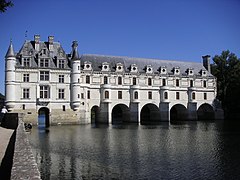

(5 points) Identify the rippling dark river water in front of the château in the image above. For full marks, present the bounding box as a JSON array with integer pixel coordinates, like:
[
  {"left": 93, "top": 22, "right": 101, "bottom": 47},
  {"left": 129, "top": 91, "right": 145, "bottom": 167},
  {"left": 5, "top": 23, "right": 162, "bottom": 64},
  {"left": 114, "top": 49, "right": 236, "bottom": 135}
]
[{"left": 28, "top": 121, "right": 240, "bottom": 180}]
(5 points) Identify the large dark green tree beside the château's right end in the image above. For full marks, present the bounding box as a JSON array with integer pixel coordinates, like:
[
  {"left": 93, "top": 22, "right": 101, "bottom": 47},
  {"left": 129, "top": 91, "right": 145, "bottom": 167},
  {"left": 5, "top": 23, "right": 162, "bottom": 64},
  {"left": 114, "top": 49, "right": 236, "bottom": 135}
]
[{"left": 212, "top": 50, "right": 240, "bottom": 119}]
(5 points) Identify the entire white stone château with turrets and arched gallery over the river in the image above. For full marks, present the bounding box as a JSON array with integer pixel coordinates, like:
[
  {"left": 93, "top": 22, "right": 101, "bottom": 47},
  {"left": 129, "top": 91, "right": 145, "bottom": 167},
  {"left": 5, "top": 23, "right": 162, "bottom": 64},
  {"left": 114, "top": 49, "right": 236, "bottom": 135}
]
[{"left": 5, "top": 35, "right": 224, "bottom": 124}]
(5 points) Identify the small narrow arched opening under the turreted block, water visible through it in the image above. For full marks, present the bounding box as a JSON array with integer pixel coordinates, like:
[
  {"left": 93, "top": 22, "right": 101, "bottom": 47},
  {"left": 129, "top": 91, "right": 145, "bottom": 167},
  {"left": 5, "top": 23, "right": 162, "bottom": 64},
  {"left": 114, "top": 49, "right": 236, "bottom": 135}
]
[{"left": 38, "top": 107, "right": 50, "bottom": 128}]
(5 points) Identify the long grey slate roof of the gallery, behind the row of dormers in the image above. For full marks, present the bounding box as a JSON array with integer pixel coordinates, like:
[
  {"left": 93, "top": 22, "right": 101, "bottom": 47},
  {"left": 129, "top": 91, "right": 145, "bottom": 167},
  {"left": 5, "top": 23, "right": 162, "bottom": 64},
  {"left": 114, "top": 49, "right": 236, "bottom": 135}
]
[{"left": 81, "top": 54, "right": 212, "bottom": 76}]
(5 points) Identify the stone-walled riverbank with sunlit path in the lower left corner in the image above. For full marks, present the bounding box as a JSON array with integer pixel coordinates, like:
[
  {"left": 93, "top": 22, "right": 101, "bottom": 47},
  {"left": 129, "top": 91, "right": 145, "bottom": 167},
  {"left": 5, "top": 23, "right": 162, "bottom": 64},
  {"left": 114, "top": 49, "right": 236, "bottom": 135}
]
[{"left": 0, "top": 113, "right": 41, "bottom": 180}]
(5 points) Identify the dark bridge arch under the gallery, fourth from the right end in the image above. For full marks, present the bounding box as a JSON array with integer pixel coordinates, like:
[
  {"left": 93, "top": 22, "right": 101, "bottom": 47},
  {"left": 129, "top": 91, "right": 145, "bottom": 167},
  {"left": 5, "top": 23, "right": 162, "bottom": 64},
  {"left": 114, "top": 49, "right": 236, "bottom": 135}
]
[{"left": 112, "top": 104, "right": 130, "bottom": 124}]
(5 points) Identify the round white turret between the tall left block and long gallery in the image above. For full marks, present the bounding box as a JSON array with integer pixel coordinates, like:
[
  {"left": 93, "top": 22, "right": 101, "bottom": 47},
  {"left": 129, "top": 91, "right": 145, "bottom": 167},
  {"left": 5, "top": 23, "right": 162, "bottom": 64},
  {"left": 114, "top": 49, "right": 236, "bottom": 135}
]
[{"left": 71, "top": 41, "right": 81, "bottom": 111}]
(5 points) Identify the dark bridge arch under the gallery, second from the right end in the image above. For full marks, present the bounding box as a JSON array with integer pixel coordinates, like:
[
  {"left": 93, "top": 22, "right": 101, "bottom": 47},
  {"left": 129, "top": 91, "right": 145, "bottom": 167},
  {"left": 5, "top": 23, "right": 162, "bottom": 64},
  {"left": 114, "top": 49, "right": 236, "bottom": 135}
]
[{"left": 170, "top": 104, "right": 188, "bottom": 121}]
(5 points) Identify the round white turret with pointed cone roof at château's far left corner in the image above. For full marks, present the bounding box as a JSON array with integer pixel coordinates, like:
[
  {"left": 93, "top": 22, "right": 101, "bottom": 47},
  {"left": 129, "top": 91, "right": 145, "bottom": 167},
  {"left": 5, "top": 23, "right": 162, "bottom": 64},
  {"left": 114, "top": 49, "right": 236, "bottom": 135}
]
[{"left": 5, "top": 40, "right": 16, "bottom": 111}]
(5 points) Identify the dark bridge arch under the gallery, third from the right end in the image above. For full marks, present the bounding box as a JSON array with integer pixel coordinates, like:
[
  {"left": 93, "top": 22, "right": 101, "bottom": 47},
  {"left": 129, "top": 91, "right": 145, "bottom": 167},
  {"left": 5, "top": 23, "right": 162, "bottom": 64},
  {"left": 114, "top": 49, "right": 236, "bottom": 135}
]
[{"left": 140, "top": 103, "right": 160, "bottom": 124}]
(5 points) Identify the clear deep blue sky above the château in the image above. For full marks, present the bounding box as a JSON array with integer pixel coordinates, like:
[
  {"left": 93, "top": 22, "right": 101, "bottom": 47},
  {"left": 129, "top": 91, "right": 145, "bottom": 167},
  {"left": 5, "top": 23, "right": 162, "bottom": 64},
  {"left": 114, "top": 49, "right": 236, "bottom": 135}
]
[{"left": 0, "top": 0, "right": 240, "bottom": 94}]
